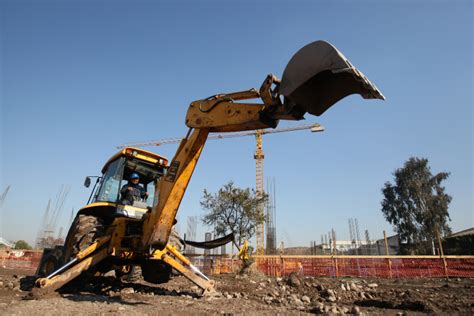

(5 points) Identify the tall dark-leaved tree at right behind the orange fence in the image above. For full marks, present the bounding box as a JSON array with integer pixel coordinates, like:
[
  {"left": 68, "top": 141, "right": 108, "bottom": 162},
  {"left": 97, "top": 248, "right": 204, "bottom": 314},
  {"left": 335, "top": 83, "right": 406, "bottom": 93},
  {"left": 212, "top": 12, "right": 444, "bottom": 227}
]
[{"left": 382, "top": 157, "right": 451, "bottom": 252}]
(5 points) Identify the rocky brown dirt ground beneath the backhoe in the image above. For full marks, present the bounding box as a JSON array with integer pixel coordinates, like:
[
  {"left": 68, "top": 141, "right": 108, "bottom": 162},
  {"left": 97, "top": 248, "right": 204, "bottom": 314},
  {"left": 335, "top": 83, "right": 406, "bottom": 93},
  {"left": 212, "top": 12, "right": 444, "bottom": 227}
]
[{"left": 0, "top": 270, "right": 474, "bottom": 315}]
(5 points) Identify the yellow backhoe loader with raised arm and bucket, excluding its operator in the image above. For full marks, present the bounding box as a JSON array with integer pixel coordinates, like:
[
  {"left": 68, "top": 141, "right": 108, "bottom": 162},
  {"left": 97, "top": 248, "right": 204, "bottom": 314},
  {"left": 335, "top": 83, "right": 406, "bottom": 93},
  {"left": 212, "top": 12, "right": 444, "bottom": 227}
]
[{"left": 33, "top": 41, "right": 384, "bottom": 293}]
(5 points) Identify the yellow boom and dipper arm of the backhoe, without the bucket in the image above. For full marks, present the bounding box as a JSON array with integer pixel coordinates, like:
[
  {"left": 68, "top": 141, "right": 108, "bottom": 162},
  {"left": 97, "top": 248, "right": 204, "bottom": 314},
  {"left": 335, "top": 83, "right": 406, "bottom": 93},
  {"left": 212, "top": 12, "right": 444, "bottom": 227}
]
[{"left": 143, "top": 79, "right": 278, "bottom": 250}]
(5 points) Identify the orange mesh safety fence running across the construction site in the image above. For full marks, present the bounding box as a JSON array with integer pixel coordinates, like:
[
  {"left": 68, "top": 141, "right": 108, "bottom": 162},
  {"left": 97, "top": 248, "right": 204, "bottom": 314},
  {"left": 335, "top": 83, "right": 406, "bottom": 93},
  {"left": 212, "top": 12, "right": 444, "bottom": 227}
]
[{"left": 0, "top": 250, "right": 474, "bottom": 278}]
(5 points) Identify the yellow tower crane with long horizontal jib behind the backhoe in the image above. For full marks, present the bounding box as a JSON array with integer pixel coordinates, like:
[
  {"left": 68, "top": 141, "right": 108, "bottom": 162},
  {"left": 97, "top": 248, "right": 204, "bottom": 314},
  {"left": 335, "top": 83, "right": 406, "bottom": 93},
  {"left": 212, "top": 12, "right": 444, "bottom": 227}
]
[{"left": 117, "top": 124, "right": 324, "bottom": 255}]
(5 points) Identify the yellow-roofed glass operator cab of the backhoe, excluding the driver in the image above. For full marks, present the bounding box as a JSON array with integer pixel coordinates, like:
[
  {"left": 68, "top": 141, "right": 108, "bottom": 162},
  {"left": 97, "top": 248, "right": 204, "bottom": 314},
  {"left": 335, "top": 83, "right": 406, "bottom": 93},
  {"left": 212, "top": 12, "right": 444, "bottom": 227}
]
[{"left": 84, "top": 147, "right": 168, "bottom": 219}]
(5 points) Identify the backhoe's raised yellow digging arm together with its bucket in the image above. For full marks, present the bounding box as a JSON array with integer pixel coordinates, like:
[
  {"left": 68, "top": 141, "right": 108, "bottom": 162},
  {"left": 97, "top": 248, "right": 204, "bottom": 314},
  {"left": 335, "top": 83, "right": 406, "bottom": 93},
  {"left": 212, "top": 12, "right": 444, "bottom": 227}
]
[{"left": 142, "top": 41, "right": 385, "bottom": 250}]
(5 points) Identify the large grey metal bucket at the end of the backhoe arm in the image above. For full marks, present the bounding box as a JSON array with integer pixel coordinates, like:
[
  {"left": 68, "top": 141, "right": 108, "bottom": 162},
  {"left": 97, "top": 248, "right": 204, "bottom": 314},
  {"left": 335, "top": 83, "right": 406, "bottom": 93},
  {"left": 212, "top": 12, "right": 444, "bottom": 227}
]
[{"left": 279, "top": 41, "right": 385, "bottom": 119}]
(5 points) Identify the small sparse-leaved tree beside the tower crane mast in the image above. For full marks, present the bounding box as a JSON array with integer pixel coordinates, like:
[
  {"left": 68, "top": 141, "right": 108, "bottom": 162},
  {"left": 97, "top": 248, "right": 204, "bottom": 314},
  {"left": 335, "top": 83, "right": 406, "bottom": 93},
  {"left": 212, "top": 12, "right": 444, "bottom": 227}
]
[{"left": 201, "top": 181, "right": 267, "bottom": 250}]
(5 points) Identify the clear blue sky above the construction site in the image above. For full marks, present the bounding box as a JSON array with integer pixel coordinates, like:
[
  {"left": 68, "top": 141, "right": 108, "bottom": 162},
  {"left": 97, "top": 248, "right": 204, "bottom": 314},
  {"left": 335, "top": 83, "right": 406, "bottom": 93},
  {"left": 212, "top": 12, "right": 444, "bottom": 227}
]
[{"left": 0, "top": 0, "right": 474, "bottom": 246}]
